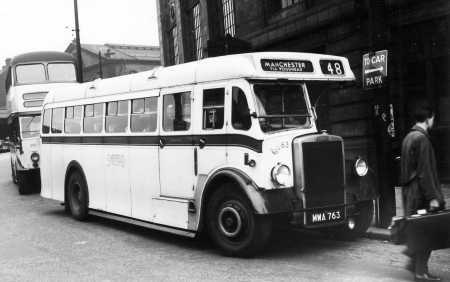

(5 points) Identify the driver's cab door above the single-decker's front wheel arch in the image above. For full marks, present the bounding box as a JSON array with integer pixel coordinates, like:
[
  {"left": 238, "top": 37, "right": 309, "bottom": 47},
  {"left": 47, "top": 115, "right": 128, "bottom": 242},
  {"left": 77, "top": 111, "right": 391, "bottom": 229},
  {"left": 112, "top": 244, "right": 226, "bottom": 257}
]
[{"left": 193, "top": 83, "right": 231, "bottom": 184}]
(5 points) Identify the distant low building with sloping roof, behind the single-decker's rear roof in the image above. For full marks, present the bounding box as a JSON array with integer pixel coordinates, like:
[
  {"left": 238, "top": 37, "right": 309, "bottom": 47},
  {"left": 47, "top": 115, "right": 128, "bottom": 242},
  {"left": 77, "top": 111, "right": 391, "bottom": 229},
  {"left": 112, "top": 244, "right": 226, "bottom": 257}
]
[{"left": 65, "top": 42, "right": 161, "bottom": 81}]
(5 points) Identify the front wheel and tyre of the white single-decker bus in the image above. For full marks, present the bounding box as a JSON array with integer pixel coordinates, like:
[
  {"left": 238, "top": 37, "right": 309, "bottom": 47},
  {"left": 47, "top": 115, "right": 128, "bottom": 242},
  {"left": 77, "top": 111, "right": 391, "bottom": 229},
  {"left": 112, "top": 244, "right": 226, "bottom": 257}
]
[{"left": 207, "top": 184, "right": 272, "bottom": 257}]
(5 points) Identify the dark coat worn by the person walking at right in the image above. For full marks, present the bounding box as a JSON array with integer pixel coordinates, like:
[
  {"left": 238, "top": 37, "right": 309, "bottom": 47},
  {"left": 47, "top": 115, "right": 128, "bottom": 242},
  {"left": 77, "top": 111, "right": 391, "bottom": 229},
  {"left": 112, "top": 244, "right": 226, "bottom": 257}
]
[{"left": 401, "top": 126, "right": 444, "bottom": 215}]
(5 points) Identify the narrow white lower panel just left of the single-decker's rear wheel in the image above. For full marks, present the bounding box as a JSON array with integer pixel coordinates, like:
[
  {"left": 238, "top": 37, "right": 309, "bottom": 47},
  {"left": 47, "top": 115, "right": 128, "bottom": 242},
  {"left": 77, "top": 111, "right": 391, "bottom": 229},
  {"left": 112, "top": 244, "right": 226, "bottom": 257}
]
[{"left": 50, "top": 144, "right": 67, "bottom": 202}]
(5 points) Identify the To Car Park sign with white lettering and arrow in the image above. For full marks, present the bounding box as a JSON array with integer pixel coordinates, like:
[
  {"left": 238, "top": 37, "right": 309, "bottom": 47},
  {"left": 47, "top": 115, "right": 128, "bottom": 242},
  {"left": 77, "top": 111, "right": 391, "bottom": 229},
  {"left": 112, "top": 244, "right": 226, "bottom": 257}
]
[{"left": 362, "top": 50, "right": 388, "bottom": 89}]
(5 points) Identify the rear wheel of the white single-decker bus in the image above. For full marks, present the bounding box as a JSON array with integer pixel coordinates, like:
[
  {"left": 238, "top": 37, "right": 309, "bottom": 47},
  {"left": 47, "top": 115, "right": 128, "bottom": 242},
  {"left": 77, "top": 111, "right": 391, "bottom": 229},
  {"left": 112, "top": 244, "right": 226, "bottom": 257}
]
[{"left": 66, "top": 171, "right": 89, "bottom": 221}]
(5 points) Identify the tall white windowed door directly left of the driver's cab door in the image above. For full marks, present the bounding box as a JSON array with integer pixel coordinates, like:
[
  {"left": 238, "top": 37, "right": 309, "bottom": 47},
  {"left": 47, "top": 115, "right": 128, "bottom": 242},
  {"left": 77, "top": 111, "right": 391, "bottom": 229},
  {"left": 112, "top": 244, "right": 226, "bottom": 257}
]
[{"left": 159, "top": 86, "right": 194, "bottom": 199}]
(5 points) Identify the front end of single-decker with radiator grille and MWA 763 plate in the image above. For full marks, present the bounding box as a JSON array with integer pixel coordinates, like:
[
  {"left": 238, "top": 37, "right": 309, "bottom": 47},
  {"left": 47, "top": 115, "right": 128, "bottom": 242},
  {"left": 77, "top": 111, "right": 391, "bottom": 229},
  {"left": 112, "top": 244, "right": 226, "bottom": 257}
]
[{"left": 249, "top": 54, "right": 374, "bottom": 236}]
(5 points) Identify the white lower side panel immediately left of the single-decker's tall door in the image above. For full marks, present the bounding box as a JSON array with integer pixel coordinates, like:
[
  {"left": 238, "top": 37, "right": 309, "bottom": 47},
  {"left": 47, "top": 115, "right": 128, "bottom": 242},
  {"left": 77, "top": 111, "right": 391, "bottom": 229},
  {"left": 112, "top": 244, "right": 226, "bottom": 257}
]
[{"left": 128, "top": 146, "right": 159, "bottom": 221}]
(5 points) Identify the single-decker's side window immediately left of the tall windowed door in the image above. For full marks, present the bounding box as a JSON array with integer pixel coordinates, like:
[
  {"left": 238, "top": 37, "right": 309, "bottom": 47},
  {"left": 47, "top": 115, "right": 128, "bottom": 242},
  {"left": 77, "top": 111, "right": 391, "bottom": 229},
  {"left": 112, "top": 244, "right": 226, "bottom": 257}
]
[{"left": 131, "top": 97, "right": 158, "bottom": 132}]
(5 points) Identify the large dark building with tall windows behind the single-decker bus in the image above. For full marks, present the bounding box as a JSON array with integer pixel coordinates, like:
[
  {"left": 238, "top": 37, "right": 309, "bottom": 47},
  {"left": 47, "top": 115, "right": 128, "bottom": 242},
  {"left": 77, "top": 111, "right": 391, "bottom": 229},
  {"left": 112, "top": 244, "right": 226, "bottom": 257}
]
[{"left": 158, "top": 0, "right": 450, "bottom": 225}]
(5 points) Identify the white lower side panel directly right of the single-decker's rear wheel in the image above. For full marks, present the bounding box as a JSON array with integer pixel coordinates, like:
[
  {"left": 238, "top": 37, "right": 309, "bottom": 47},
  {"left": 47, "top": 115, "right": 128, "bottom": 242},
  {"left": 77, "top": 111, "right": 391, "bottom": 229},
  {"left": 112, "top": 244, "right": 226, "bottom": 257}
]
[{"left": 81, "top": 145, "right": 106, "bottom": 211}]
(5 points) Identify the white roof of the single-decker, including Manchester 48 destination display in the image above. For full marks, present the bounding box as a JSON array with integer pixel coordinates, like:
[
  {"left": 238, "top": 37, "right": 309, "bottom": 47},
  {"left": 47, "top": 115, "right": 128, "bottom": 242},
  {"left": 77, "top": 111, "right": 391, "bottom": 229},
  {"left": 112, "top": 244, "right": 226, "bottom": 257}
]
[{"left": 46, "top": 52, "right": 355, "bottom": 103}]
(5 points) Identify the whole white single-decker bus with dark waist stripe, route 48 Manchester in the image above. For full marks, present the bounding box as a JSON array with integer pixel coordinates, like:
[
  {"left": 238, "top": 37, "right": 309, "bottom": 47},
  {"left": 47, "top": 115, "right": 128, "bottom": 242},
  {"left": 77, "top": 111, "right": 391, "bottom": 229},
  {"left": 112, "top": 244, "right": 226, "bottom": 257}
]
[{"left": 41, "top": 52, "right": 372, "bottom": 256}]
